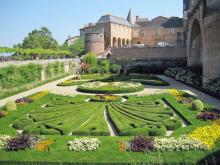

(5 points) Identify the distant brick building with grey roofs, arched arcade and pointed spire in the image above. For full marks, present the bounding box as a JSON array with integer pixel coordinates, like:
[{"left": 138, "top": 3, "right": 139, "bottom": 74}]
[{"left": 80, "top": 10, "right": 184, "bottom": 52}]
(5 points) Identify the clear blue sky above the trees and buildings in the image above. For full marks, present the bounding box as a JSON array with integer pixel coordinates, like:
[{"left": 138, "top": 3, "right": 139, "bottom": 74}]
[{"left": 0, "top": 0, "right": 182, "bottom": 46}]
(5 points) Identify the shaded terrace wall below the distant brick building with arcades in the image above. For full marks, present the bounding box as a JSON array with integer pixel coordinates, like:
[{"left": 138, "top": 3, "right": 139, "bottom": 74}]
[{"left": 110, "top": 47, "right": 187, "bottom": 73}]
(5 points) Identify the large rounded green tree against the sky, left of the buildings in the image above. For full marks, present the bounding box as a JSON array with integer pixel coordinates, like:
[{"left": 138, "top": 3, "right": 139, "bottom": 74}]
[{"left": 19, "top": 27, "right": 58, "bottom": 49}]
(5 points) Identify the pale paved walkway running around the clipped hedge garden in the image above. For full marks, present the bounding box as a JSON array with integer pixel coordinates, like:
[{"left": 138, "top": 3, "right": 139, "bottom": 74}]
[{"left": 0, "top": 75, "right": 220, "bottom": 109}]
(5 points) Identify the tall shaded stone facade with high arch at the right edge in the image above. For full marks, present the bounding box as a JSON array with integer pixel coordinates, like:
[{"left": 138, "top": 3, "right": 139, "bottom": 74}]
[{"left": 183, "top": 0, "right": 220, "bottom": 82}]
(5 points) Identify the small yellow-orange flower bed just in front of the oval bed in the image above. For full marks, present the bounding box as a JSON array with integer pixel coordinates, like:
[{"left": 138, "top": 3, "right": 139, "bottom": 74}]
[{"left": 90, "top": 95, "right": 122, "bottom": 102}]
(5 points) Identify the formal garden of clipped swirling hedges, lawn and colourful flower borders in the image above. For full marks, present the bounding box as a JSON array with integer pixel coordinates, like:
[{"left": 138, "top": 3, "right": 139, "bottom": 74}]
[{"left": 0, "top": 64, "right": 220, "bottom": 164}]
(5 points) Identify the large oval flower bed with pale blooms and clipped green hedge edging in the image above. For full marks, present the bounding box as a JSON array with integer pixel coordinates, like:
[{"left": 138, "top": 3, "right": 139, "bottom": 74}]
[{"left": 77, "top": 81, "right": 144, "bottom": 94}]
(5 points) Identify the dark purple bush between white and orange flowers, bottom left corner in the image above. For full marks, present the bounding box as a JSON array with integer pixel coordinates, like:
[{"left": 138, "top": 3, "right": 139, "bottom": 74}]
[{"left": 5, "top": 134, "right": 37, "bottom": 151}]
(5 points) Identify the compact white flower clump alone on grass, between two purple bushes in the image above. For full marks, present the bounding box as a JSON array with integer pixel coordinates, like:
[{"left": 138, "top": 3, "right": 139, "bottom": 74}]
[{"left": 68, "top": 138, "right": 100, "bottom": 151}]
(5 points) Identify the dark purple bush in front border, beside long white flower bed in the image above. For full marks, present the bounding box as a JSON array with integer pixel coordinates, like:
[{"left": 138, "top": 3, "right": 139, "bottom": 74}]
[{"left": 128, "top": 136, "right": 154, "bottom": 152}]
